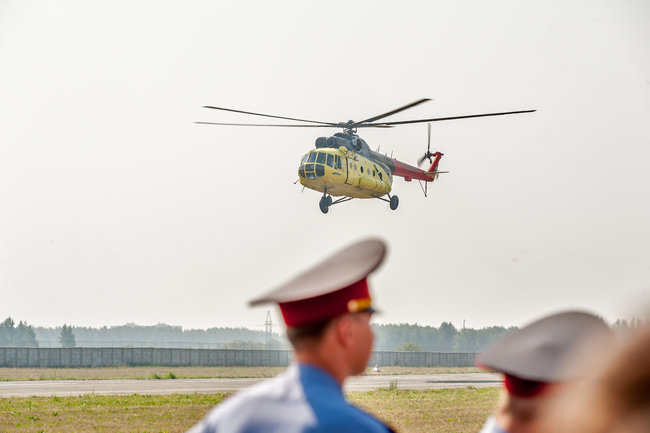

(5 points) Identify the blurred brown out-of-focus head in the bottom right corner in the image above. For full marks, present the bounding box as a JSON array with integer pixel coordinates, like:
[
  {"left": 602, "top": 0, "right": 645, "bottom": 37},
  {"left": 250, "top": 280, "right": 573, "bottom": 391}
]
[{"left": 545, "top": 323, "right": 650, "bottom": 433}]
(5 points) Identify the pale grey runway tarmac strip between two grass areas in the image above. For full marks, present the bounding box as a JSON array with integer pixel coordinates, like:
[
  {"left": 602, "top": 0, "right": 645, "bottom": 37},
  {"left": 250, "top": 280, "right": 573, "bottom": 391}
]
[{"left": 0, "top": 373, "right": 501, "bottom": 397}]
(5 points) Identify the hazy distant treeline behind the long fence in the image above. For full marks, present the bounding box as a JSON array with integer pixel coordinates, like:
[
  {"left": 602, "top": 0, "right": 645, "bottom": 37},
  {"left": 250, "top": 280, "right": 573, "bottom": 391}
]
[{"left": 0, "top": 318, "right": 647, "bottom": 352}]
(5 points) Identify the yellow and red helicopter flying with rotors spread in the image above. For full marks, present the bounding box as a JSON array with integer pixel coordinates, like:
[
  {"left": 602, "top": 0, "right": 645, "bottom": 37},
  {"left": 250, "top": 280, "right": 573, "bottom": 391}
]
[{"left": 195, "top": 98, "right": 537, "bottom": 214}]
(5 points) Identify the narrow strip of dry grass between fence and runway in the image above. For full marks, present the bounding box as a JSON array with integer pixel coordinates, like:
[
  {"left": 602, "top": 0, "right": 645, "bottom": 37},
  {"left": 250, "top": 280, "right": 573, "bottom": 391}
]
[{"left": 0, "top": 367, "right": 481, "bottom": 381}]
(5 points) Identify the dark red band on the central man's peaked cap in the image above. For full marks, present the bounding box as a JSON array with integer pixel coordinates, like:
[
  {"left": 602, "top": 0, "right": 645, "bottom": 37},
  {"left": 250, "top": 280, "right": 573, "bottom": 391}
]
[{"left": 279, "top": 278, "right": 370, "bottom": 327}]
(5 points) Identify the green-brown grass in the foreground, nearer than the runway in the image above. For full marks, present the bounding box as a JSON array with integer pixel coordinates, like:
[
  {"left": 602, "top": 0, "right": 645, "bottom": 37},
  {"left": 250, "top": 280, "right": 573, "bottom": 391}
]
[{"left": 0, "top": 388, "right": 499, "bottom": 433}]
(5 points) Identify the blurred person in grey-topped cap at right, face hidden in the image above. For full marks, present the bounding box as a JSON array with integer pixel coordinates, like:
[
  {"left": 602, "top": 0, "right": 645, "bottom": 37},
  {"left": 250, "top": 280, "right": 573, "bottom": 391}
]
[{"left": 476, "top": 311, "right": 614, "bottom": 433}]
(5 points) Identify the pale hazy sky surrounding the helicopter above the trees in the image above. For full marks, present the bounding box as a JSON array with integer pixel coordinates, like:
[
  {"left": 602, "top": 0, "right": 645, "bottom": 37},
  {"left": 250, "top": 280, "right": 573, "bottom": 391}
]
[{"left": 0, "top": 0, "right": 650, "bottom": 329}]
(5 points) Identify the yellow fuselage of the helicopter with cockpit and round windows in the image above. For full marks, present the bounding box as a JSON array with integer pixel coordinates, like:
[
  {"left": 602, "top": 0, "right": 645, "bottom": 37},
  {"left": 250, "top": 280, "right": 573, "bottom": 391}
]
[{"left": 298, "top": 147, "right": 391, "bottom": 198}]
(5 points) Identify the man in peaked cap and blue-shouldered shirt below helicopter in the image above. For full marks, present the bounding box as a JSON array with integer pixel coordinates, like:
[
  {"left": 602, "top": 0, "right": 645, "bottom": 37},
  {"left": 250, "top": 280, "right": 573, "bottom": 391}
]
[{"left": 185, "top": 239, "right": 391, "bottom": 433}]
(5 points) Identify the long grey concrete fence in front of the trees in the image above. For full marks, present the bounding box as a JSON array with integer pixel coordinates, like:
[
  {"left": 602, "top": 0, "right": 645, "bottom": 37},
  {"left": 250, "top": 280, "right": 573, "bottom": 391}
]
[{"left": 0, "top": 347, "right": 476, "bottom": 367}]
